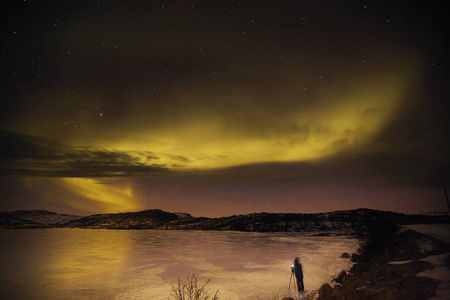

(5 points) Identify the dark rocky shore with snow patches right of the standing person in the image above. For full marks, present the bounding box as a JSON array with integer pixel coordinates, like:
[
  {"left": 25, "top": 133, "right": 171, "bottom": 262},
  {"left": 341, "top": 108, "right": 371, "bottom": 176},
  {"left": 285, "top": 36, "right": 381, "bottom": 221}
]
[{"left": 314, "top": 230, "right": 450, "bottom": 300}]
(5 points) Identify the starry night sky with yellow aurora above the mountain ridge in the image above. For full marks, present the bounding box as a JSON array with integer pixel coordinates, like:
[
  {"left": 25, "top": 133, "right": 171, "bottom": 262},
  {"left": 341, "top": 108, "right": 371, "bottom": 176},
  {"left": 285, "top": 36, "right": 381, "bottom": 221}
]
[{"left": 0, "top": 0, "right": 450, "bottom": 216}]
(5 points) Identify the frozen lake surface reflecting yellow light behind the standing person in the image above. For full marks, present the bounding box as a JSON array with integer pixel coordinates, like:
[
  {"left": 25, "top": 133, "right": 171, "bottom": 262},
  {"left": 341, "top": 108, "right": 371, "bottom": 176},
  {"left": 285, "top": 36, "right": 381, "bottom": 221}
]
[{"left": 0, "top": 229, "right": 358, "bottom": 300}]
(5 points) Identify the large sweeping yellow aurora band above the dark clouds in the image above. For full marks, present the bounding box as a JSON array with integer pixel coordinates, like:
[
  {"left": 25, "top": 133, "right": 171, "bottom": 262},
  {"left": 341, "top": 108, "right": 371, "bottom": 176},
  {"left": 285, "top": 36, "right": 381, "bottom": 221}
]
[{"left": 102, "top": 71, "right": 407, "bottom": 170}]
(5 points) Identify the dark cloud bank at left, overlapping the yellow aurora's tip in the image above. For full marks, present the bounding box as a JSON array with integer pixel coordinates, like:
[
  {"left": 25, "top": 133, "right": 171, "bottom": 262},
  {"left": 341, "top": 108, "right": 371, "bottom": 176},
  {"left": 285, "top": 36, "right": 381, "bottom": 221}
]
[{"left": 0, "top": 131, "right": 172, "bottom": 177}]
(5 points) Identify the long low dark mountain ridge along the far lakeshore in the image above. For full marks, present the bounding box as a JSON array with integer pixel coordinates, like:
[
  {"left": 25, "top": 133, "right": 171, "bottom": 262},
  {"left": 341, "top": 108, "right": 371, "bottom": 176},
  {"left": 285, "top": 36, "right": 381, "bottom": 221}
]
[{"left": 0, "top": 209, "right": 450, "bottom": 232}]
